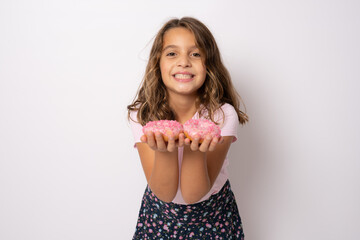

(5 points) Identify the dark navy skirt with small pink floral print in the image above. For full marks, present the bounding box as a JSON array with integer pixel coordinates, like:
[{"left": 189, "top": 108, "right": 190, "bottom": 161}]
[{"left": 133, "top": 180, "right": 244, "bottom": 240}]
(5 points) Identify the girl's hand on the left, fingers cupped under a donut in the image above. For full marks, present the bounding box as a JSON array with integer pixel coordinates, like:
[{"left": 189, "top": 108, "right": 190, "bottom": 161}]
[{"left": 140, "top": 132, "right": 185, "bottom": 152}]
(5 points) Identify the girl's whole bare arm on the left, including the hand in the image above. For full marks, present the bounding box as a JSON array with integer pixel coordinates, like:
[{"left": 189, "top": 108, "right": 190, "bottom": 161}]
[{"left": 136, "top": 133, "right": 184, "bottom": 202}]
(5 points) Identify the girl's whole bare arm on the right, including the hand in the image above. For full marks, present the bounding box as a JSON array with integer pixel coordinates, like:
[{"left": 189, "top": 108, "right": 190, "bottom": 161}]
[{"left": 180, "top": 136, "right": 233, "bottom": 204}]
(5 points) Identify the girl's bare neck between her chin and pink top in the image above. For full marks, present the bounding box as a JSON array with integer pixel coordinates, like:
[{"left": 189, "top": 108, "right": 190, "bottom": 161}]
[{"left": 169, "top": 94, "right": 197, "bottom": 124}]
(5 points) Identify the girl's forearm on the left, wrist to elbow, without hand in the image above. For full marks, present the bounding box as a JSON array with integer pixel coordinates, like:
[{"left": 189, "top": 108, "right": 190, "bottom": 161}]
[{"left": 149, "top": 150, "right": 179, "bottom": 202}]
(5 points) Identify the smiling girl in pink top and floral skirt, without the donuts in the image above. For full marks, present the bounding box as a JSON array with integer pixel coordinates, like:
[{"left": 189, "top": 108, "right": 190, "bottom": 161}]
[{"left": 128, "top": 17, "right": 248, "bottom": 240}]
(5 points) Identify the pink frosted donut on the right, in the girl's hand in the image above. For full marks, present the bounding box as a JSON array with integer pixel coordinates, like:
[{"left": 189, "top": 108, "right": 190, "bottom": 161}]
[{"left": 183, "top": 119, "right": 221, "bottom": 142}]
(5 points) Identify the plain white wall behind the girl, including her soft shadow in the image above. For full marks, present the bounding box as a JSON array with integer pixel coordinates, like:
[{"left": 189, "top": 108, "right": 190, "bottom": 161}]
[{"left": 0, "top": 0, "right": 360, "bottom": 240}]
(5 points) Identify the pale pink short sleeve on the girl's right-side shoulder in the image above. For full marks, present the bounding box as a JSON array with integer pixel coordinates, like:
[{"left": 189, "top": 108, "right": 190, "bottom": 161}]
[{"left": 216, "top": 103, "right": 239, "bottom": 142}]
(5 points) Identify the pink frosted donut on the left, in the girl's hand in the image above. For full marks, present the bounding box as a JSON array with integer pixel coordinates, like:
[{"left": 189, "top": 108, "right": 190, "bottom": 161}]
[{"left": 142, "top": 120, "right": 183, "bottom": 142}]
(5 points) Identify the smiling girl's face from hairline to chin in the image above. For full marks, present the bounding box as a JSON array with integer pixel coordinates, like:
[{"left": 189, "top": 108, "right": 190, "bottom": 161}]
[{"left": 160, "top": 27, "right": 206, "bottom": 99}]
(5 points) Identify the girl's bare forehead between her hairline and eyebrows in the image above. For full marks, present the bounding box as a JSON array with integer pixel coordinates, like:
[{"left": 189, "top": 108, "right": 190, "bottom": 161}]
[{"left": 163, "top": 27, "right": 196, "bottom": 49}]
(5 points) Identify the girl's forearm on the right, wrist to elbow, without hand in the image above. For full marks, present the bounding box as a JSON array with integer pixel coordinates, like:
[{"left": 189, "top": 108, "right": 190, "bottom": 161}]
[{"left": 180, "top": 146, "right": 211, "bottom": 204}]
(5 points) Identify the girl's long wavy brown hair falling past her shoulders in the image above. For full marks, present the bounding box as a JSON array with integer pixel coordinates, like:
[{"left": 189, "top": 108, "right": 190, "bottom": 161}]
[{"left": 127, "top": 17, "right": 249, "bottom": 125}]
